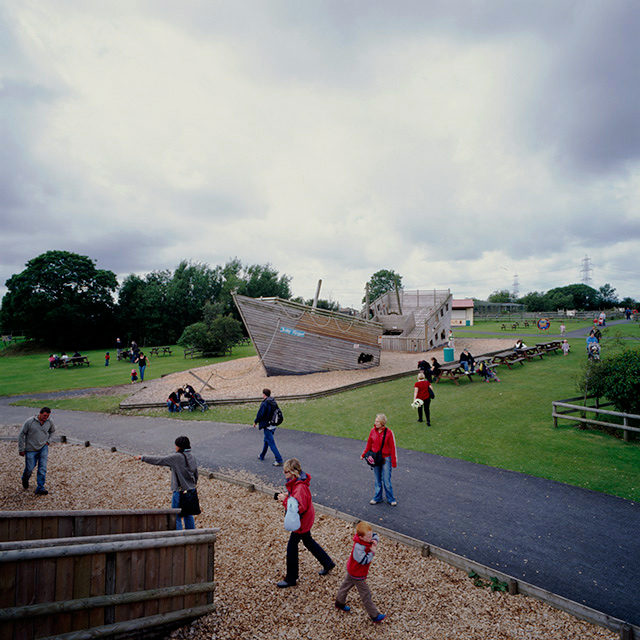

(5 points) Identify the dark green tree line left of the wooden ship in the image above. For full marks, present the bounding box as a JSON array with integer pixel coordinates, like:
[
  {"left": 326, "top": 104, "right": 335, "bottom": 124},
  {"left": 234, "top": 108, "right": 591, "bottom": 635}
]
[{"left": 0, "top": 251, "right": 291, "bottom": 349}]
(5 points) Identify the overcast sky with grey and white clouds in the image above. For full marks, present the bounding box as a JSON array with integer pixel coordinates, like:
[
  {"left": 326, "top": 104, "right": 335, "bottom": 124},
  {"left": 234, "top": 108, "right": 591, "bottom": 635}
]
[{"left": 0, "top": 0, "right": 640, "bottom": 306}]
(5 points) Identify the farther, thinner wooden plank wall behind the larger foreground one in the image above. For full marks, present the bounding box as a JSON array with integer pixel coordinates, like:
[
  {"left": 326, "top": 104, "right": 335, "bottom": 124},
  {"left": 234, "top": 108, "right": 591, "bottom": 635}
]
[{"left": 0, "top": 509, "right": 180, "bottom": 542}]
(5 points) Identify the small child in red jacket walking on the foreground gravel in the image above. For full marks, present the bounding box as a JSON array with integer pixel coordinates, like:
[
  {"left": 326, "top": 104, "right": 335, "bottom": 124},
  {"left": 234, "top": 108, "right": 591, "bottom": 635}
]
[{"left": 336, "top": 521, "right": 387, "bottom": 622}]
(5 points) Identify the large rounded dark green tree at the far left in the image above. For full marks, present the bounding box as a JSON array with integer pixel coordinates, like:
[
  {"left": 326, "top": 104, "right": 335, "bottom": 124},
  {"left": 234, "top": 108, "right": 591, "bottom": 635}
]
[{"left": 0, "top": 251, "right": 118, "bottom": 350}]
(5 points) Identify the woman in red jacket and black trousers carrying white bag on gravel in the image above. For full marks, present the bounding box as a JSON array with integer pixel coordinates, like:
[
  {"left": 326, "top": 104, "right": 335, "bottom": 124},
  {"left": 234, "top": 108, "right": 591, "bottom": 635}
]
[{"left": 276, "top": 458, "right": 336, "bottom": 589}]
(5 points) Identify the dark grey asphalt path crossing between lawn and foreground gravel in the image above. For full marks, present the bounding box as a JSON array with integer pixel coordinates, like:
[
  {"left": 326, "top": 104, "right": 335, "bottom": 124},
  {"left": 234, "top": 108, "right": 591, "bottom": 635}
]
[{"left": 0, "top": 398, "right": 640, "bottom": 625}]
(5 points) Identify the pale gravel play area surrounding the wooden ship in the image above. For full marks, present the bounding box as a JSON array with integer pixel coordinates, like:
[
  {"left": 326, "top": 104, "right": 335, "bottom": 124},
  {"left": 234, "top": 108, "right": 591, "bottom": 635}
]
[{"left": 125, "top": 339, "right": 515, "bottom": 405}]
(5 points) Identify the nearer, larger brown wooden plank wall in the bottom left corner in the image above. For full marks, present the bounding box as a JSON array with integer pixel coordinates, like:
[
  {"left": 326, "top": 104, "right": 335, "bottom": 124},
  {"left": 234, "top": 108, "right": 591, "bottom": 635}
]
[{"left": 0, "top": 529, "right": 218, "bottom": 640}]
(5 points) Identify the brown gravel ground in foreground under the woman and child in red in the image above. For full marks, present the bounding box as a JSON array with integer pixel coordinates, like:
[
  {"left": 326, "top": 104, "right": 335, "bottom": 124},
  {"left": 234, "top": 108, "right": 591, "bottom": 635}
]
[{"left": 0, "top": 444, "right": 617, "bottom": 640}]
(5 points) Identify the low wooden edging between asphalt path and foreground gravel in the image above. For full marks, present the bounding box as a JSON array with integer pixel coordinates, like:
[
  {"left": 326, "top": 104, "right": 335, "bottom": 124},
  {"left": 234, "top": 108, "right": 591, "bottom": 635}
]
[{"left": 33, "top": 436, "right": 640, "bottom": 640}]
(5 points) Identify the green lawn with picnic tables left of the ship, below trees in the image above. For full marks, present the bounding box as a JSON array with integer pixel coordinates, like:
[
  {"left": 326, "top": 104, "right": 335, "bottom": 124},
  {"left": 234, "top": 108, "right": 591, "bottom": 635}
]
[{"left": 0, "top": 345, "right": 256, "bottom": 396}]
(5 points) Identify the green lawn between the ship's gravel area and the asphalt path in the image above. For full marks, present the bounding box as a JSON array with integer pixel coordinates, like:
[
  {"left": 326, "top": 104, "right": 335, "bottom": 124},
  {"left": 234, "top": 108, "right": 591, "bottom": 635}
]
[{"left": 6, "top": 338, "right": 640, "bottom": 500}]
